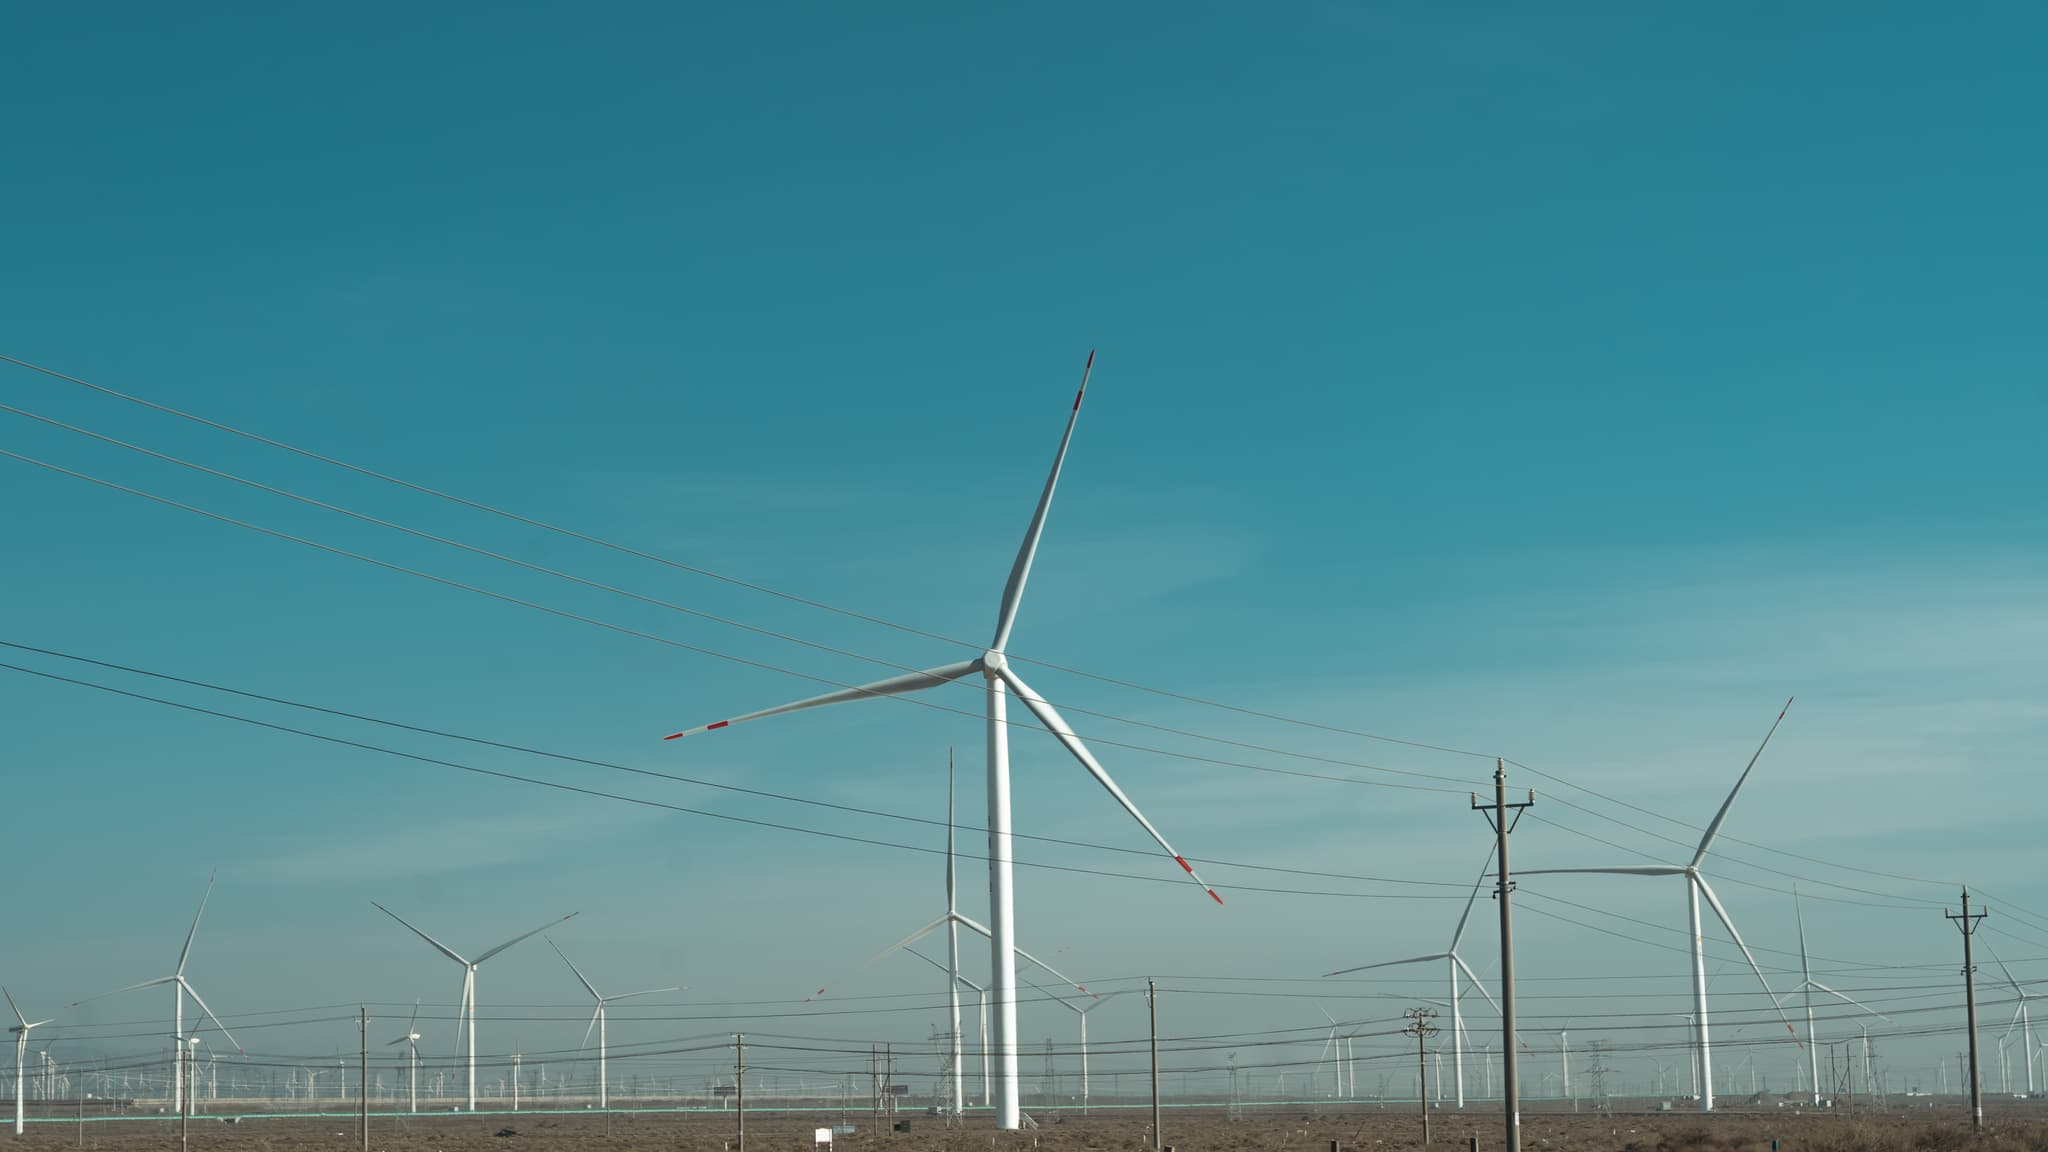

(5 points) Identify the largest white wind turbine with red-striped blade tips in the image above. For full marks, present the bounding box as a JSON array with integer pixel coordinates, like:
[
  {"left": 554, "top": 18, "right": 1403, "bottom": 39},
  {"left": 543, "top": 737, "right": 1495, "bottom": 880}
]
[{"left": 668, "top": 353, "right": 1223, "bottom": 1129}]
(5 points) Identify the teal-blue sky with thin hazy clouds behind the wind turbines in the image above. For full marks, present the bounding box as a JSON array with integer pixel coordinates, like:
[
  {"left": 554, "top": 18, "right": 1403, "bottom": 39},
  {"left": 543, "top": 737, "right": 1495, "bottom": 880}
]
[{"left": 0, "top": 4, "right": 2048, "bottom": 1091}]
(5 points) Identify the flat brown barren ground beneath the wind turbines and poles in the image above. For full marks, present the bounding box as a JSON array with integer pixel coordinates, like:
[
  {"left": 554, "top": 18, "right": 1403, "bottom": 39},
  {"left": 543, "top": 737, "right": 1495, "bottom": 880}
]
[{"left": 8, "top": 1103, "right": 2048, "bottom": 1152}]
